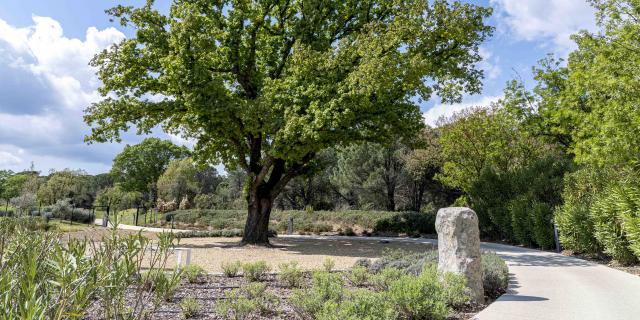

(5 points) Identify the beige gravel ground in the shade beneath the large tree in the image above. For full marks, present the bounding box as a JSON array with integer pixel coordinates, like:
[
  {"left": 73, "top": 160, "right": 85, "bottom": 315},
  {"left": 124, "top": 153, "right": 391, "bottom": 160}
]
[{"left": 171, "top": 238, "right": 434, "bottom": 272}]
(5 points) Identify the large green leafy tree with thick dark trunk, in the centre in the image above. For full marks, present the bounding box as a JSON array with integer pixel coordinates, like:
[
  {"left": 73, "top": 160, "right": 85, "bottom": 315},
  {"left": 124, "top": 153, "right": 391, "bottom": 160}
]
[{"left": 85, "top": 0, "right": 492, "bottom": 244}]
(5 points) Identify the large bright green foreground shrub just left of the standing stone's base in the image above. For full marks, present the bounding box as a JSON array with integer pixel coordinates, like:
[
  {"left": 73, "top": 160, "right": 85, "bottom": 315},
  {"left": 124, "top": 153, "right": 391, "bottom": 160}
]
[{"left": 388, "top": 267, "right": 450, "bottom": 320}]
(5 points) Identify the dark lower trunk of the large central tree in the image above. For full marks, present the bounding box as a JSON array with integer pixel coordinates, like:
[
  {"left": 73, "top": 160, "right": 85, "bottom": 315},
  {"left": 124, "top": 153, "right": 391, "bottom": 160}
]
[{"left": 242, "top": 192, "right": 274, "bottom": 245}]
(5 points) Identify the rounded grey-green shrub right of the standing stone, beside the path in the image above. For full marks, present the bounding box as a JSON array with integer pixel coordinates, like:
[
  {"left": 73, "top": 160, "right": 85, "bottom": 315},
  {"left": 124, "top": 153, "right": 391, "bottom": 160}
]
[{"left": 482, "top": 252, "right": 509, "bottom": 299}]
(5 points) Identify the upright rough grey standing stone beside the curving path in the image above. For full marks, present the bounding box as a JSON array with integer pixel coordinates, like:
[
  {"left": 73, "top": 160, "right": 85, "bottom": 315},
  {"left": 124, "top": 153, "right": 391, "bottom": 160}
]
[{"left": 436, "top": 207, "right": 484, "bottom": 303}]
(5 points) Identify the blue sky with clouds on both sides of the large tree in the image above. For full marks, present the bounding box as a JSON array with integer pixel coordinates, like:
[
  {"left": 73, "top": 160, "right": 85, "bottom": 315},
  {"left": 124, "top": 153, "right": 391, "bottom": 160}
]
[{"left": 0, "top": 0, "right": 595, "bottom": 173}]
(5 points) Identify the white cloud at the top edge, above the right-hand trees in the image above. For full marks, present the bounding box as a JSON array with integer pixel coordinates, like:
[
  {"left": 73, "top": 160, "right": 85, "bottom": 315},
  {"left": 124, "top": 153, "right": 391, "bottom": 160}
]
[{"left": 491, "top": 0, "right": 595, "bottom": 54}]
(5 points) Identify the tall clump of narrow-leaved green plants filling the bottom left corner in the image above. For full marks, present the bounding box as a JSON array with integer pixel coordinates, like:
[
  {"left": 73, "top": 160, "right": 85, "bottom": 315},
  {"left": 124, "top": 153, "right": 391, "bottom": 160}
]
[{"left": 0, "top": 218, "right": 179, "bottom": 319}]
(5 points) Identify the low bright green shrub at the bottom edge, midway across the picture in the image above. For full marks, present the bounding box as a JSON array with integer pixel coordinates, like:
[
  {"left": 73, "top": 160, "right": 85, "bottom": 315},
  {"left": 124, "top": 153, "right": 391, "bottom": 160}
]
[{"left": 289, "top": 271, "right": 344, "bottom": 316}]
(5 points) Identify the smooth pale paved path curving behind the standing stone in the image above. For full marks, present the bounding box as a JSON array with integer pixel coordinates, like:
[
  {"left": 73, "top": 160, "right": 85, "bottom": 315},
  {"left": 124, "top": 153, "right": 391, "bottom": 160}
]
[{"left": 94, "top": 225, "right": 640, "bottom": 320}]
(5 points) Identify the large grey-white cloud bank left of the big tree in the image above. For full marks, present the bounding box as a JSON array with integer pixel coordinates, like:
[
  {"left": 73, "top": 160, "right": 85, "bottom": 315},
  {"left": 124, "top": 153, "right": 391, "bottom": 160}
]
[{"left": 0, "top": 16, "right": 125, "bottom": 171}]
